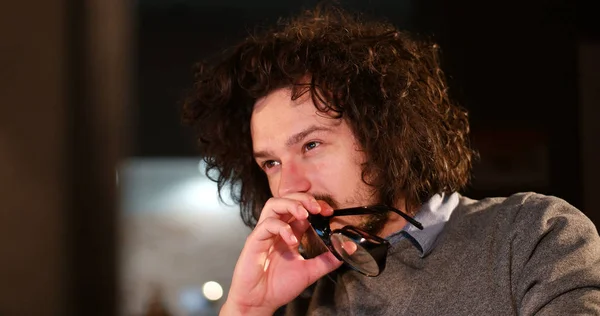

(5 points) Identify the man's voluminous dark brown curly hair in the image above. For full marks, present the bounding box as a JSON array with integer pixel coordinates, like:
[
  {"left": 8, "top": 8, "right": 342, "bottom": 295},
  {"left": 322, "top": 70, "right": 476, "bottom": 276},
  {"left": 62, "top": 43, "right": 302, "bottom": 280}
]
[{"left": 182, "top": 7, "right": 476, "bottom": 227}]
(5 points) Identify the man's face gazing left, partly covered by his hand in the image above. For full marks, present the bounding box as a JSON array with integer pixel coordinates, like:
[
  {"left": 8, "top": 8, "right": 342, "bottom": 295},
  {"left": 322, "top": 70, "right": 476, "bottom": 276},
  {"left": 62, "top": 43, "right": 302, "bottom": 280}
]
[{"left": 251, "top": 89, "right": 381, "bottom": 233}]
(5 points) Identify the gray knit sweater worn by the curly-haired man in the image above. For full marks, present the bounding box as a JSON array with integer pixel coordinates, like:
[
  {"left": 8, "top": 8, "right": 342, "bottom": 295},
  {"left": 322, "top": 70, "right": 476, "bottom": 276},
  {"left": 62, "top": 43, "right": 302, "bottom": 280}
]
[{"left": 285, "top": 193, "right": 600, "bottom": 315}]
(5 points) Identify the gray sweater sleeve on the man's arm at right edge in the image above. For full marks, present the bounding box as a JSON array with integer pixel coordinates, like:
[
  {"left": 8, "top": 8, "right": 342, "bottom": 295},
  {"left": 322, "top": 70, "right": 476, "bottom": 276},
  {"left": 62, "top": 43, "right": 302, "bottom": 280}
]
[{"left": 511, "top": 194, "right": 600, "bottom": 315}]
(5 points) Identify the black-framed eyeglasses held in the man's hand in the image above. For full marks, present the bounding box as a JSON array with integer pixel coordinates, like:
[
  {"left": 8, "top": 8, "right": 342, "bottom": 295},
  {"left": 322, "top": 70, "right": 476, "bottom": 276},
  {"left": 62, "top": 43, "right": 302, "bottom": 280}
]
[{"left": 308, "top": 205, "right": 423, "bottom": 277}]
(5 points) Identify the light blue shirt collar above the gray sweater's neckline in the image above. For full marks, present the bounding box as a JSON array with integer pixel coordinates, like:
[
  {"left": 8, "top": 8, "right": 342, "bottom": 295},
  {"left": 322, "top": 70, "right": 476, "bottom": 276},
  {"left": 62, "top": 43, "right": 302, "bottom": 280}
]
[{"left": 388, "top": 192, "right": 459, "bottom": 257}]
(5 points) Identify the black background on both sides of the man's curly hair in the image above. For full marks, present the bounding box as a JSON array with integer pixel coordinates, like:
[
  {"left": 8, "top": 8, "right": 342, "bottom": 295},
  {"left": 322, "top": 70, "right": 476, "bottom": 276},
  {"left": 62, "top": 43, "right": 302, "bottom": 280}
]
[{"left": 134, "top": 0, "right": 598, "bottom": 215}]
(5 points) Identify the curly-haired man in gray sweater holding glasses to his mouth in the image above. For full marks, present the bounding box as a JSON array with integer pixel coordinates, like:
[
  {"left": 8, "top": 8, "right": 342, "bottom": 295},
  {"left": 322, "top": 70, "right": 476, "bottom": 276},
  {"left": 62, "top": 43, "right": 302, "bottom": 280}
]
[{"left": 184, "top": 5, "right": 600, "bottom": 315}]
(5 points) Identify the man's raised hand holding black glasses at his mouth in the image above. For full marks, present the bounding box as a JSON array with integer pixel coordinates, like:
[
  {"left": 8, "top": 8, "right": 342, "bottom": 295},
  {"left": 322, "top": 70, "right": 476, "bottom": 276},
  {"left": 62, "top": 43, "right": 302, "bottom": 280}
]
[{"left": 221, "top": 193, "right": 342, "bottom": 315}]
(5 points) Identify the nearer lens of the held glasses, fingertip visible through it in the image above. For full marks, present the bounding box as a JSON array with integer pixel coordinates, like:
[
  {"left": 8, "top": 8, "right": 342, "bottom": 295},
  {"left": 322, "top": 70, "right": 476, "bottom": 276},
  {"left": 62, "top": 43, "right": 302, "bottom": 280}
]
[{"left": 331, "top": 233, "right": 379, "bottom": 276}]
